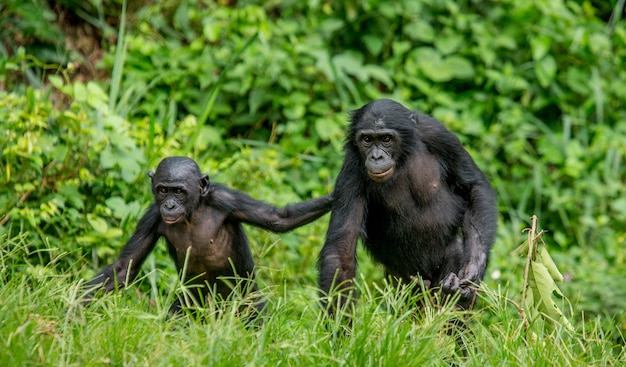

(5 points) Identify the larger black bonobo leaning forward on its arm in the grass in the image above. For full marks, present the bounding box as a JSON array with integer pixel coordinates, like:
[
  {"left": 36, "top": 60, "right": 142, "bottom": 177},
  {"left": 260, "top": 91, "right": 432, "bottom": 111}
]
[{"left": 318, "top": 99, "right": 497, "bottom": 315}]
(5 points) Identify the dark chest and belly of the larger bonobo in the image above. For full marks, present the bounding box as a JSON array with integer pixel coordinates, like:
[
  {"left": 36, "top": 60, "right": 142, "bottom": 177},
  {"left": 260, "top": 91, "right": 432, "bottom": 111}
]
[{"left": 363, "top": 171, "right": 463, "bottom": 280}]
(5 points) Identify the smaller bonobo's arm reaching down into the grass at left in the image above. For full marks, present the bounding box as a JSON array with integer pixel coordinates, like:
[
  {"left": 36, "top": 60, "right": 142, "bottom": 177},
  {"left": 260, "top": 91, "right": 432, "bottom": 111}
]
[{"left": 83, "top": 204, "right": 161, "bottom": 304}]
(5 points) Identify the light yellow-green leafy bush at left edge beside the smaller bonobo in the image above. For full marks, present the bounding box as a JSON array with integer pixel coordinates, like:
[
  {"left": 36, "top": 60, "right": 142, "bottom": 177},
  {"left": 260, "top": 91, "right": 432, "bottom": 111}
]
[{"left": 0, "top": 86, "right": 144, "bottom": 268}]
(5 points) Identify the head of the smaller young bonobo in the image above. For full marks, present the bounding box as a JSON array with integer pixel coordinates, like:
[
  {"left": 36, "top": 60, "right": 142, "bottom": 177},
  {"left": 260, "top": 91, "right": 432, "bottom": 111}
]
[{"left": 149, "top": 157, "right": 209, "bottom": 225}]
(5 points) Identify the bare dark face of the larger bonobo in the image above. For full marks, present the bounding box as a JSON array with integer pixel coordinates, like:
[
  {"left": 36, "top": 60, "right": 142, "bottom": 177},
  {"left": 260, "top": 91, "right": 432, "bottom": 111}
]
[{"left": 356, "top": 128, "right": 400, "bottom": 182}]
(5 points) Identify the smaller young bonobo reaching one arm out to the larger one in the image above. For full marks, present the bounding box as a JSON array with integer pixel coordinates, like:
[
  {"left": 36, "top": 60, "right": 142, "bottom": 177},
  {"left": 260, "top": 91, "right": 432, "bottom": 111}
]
[{"left": 84, "top": 157, "right": 332, "bottom": 314}]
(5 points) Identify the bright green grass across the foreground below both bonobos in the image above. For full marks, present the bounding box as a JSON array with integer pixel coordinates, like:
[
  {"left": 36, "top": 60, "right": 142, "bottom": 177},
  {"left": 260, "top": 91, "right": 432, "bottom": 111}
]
[{"left": 0, "top": 235, "right": 626, "bottom": 367}]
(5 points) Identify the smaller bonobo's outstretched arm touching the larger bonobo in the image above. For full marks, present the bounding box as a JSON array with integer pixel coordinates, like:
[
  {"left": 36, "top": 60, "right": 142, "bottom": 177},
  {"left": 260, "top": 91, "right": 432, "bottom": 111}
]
[{"left": 209, "top": 183, "right": 333, "bottom": 232}]
